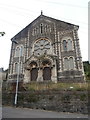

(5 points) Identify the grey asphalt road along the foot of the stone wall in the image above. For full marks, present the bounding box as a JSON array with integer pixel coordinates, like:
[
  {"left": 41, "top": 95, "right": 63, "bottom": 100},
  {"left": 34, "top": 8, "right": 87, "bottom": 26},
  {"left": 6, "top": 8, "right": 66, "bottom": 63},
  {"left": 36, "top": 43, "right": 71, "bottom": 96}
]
[{"left": 2, "top": 107, "right": 88, "bottom": 118}]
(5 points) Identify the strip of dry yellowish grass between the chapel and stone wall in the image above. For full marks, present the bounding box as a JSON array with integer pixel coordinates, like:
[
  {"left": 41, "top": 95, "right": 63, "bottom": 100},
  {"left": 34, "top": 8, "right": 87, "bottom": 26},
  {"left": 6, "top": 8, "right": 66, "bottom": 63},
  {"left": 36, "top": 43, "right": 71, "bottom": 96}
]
[{"left": 24, "top": 82, "right": 88, "bottom": 91}]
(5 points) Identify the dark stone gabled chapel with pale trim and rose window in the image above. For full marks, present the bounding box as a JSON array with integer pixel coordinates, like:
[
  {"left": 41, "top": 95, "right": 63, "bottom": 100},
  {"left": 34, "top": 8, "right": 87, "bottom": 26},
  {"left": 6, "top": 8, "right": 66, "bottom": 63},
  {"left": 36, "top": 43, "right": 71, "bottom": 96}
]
[{"left": 8, "top": 12, "right": 84, "bottom": 83}]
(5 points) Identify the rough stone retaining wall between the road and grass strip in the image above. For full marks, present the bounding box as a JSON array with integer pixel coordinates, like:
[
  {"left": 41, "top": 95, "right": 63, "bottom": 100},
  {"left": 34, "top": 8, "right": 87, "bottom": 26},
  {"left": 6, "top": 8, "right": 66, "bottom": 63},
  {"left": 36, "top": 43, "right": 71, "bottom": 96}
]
[{"left": 2, "top": 90, "right": 88, "bottom": 114}]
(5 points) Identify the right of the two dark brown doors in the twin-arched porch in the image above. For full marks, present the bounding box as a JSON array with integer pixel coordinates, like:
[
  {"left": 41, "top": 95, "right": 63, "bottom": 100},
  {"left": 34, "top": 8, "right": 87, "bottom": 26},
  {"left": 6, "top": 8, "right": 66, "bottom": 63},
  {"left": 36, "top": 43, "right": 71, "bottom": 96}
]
[{"left": 43, "top": 67, "right": 51, "bottom": 80}]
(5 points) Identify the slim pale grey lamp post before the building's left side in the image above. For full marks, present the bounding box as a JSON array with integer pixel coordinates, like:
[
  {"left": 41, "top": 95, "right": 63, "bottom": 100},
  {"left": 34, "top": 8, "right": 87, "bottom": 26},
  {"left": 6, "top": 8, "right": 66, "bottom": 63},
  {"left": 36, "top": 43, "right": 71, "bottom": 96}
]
[{"left": 12, "top": 40, "right": 21, "bottom": 106}]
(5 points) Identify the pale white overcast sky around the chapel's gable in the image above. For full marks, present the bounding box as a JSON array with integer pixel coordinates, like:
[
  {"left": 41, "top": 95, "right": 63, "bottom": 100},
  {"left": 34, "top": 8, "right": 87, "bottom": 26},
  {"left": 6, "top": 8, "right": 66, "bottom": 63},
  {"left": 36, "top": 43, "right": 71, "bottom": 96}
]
[{"left": 0, "top": 0, "right": 88, "bottom": 70}]
